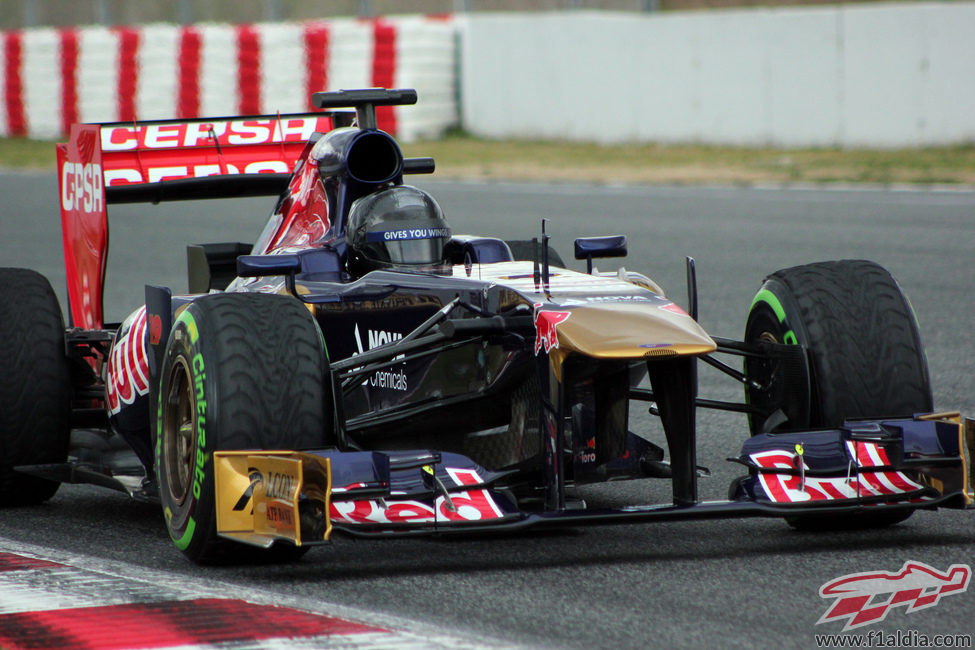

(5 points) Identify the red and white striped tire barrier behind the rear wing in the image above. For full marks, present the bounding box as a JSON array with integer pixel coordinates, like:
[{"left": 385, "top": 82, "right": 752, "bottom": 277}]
[{"left": 0, "top": 16, "right": 458, "bottom": 140}]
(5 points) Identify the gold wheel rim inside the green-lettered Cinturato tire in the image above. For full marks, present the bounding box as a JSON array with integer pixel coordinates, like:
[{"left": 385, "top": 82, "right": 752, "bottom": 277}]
[{"left": 162, "top": 357, "right": 196, "bottom": 505}]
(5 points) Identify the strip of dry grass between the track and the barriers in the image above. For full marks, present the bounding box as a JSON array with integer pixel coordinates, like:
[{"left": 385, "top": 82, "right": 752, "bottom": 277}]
[{"left": 7, "top": 134, "right": 975, "bottom": 185}]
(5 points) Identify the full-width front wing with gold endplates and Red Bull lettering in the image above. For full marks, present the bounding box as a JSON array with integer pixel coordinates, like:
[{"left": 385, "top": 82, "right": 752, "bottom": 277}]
[{"left": 214, "top": 414, "right": 975, "bottom": 547}]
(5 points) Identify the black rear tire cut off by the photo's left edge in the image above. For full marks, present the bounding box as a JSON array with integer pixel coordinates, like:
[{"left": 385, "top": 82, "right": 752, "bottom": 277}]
[{"left": 0, "top": 269, "right": 71, "bottom": 506}]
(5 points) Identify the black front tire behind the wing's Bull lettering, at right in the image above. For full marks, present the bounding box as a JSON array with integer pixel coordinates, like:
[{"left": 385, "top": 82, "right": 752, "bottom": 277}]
[{"left": 745, "top": 260, "right": 933, "bottom": 529}]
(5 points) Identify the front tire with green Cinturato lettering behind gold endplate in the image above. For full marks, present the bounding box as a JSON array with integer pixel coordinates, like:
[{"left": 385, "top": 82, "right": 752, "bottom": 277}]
[{"left": 156, "top": 294, "right": 331, "bottom": 564}]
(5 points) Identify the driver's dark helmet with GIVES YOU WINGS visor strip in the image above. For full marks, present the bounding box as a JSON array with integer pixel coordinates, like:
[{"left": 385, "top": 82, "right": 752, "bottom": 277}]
[{"left": 347, "top": 185, "right": 450, "bottom": 275}]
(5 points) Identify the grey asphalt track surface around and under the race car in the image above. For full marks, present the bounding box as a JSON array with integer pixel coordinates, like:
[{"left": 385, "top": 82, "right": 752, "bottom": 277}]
[{"left": 0, "top": 173, "right": 975, "bottom": 648}]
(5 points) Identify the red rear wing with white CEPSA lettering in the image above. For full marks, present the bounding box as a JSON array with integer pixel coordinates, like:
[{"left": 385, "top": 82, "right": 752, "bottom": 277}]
[{"left": 57, "top": 113, "right": 340, "bottom": 329}]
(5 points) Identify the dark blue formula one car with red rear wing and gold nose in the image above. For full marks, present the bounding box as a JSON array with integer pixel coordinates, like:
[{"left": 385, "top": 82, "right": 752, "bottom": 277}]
[{"left": 0, "top": 89, "right": 975, "bottom": 562}]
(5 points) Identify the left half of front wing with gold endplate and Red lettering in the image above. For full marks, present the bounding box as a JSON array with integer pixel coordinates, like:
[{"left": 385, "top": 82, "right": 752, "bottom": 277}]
[{"left": 213, "top": 450, "right": 521, "bottom": 548}]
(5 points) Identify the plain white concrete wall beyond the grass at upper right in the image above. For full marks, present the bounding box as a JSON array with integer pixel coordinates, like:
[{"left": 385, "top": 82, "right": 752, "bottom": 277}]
[{"left": 461, "top": 2, "right": 975, "bottom": 147}]
